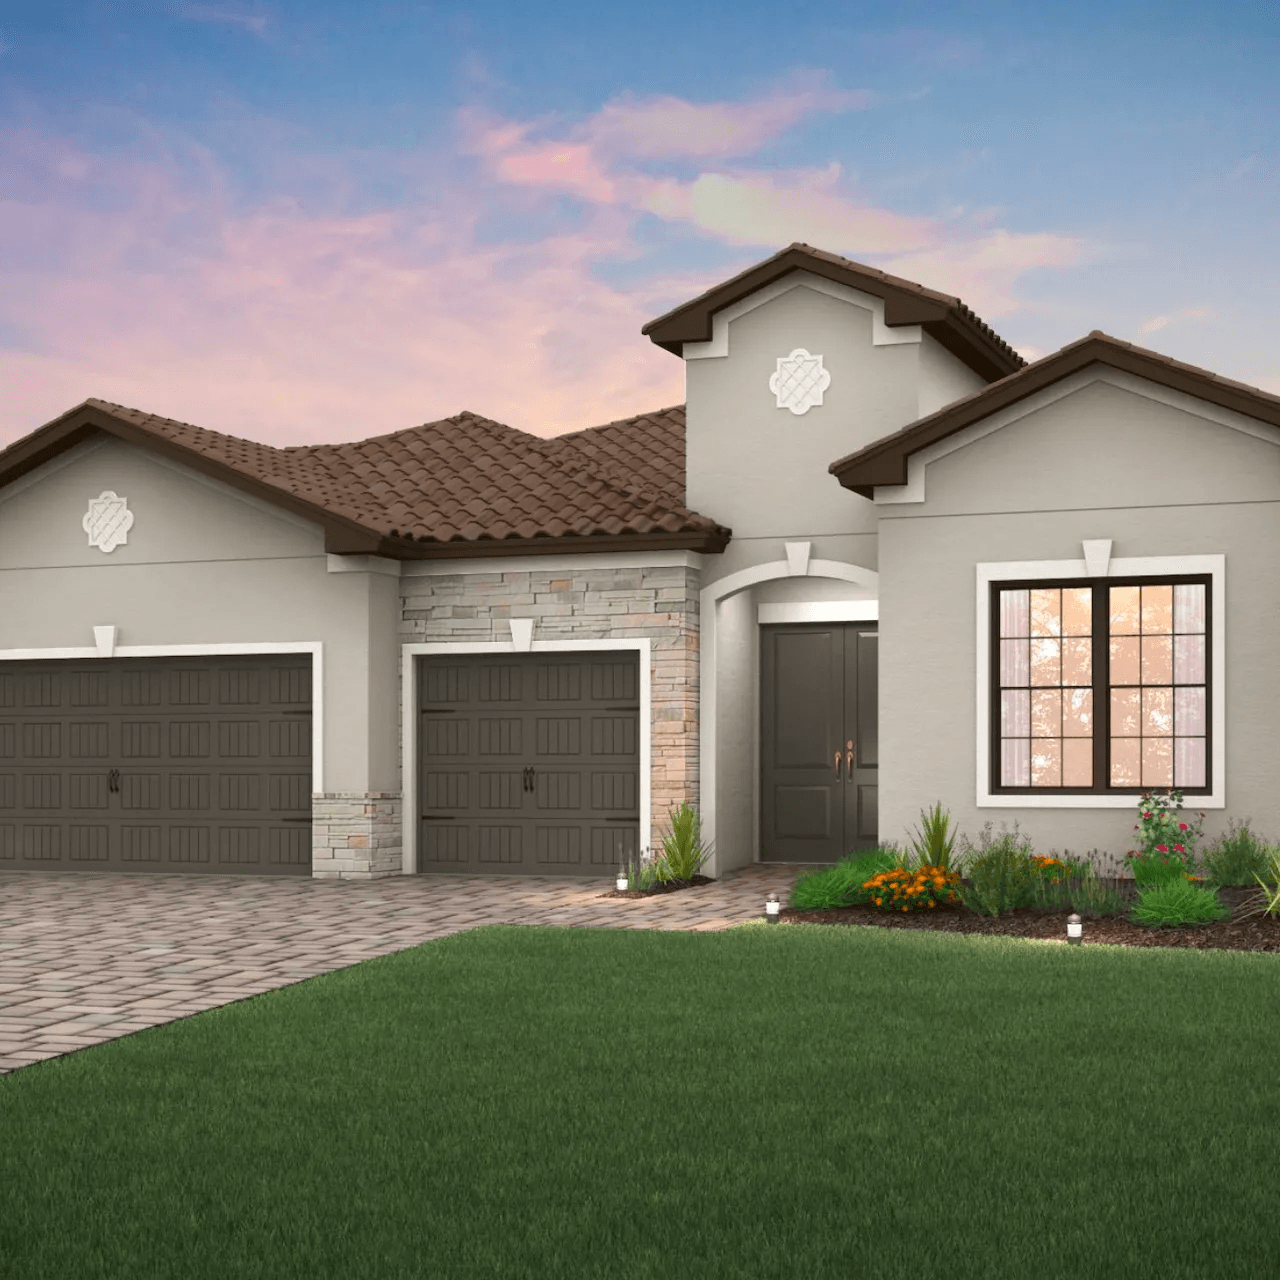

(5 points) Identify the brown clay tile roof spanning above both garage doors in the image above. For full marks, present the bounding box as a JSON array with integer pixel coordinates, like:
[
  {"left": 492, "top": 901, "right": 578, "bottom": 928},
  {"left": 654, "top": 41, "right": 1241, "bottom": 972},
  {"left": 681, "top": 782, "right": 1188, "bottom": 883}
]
[{"left": 0, "top": 399, "right": 730, "bottom": 558}]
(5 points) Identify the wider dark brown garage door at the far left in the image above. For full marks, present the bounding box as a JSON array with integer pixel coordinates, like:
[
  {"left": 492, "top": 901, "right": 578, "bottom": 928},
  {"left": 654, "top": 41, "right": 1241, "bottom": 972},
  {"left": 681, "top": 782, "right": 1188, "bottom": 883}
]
[{"left": 0, "top": 654, "right": 311, "bottom": 876}]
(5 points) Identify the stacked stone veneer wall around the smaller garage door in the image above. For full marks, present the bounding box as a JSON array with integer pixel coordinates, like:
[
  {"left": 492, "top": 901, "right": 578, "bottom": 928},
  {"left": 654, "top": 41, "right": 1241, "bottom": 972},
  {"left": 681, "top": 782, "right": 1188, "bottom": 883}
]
[{"left": 401, "top": 564, "right": 700, "bottom": 849}]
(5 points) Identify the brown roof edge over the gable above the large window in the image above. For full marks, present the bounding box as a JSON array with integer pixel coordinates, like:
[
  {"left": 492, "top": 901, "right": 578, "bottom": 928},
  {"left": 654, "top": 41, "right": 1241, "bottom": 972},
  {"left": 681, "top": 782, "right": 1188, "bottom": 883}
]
[{"left": 827, "top": 329, "right": 1280, "bottom": 498}]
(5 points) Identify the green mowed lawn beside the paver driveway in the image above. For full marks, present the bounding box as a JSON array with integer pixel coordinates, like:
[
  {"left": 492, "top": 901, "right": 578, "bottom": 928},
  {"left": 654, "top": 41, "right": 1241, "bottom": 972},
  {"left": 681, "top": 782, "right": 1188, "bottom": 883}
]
[{"left": 0, "top": 924, "right": 1280, "bottom": 1280}]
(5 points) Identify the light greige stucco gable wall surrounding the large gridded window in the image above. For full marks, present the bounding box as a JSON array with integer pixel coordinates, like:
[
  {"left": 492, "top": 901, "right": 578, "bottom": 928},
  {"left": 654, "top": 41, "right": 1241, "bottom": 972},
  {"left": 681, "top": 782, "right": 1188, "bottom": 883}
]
[{"left": 879, "top": 379, "right": 1280, "bottom": 856}]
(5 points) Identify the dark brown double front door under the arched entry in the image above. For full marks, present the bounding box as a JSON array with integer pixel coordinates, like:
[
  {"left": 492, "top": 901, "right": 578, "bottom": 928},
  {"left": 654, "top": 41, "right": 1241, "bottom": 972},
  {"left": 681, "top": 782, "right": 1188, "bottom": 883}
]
[{"left": 760, "top": 622, "right": 879, "bottom": 863}]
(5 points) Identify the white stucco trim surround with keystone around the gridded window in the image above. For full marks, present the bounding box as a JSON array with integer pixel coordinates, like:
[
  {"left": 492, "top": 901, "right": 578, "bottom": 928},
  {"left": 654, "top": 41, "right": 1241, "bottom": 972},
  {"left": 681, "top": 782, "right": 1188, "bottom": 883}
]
[{"left": 969, "top": 550, "right": 1228, "bottom": 810}]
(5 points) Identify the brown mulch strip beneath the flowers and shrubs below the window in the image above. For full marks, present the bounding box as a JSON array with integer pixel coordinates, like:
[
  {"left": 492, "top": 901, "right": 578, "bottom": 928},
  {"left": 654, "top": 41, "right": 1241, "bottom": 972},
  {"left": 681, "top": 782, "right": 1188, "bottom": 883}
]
[{"left": 773, "top": 886, "right": 1280, "bottom": 952}]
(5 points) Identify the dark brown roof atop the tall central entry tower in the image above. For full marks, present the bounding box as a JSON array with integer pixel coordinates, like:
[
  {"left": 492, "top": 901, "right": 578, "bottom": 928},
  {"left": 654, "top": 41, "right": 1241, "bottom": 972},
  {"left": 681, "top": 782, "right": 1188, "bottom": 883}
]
[{"left": 640, "top": 241, "right": 1027, "bottom": 381}]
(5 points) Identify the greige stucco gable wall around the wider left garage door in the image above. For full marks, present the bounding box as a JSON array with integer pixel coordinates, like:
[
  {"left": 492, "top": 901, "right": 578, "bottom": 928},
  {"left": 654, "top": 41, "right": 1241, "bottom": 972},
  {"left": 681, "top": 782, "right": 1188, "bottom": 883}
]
[{"left": 0, "top": 440, "right": 399, "bottom": 794}]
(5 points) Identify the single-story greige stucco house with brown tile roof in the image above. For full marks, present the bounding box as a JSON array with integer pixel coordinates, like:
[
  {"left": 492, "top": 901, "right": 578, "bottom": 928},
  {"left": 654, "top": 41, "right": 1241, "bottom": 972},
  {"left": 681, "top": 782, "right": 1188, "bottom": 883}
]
[{"left": 0, "top": 244, "right": 1264, "bottom": 878}]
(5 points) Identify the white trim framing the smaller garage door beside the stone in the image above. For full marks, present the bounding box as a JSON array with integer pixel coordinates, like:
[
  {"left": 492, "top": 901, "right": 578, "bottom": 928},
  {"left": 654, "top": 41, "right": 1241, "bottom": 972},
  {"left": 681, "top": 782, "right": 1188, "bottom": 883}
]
[{"left": 401, "top": 636, "right": 653, "bottom": 876}]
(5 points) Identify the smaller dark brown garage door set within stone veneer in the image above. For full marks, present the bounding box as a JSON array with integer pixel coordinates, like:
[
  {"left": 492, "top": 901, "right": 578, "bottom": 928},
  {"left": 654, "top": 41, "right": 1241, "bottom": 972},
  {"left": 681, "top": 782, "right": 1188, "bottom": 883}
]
[{"left": 417, "top": 653, "right": 640, "bottom": 876}]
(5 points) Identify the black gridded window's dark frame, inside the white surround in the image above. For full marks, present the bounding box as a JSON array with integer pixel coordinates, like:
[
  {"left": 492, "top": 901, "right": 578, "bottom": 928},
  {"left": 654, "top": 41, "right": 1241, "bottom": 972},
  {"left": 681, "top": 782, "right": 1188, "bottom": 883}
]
[{"left": 987, "top": 573, "right": 1215, "bottom": 797}]
